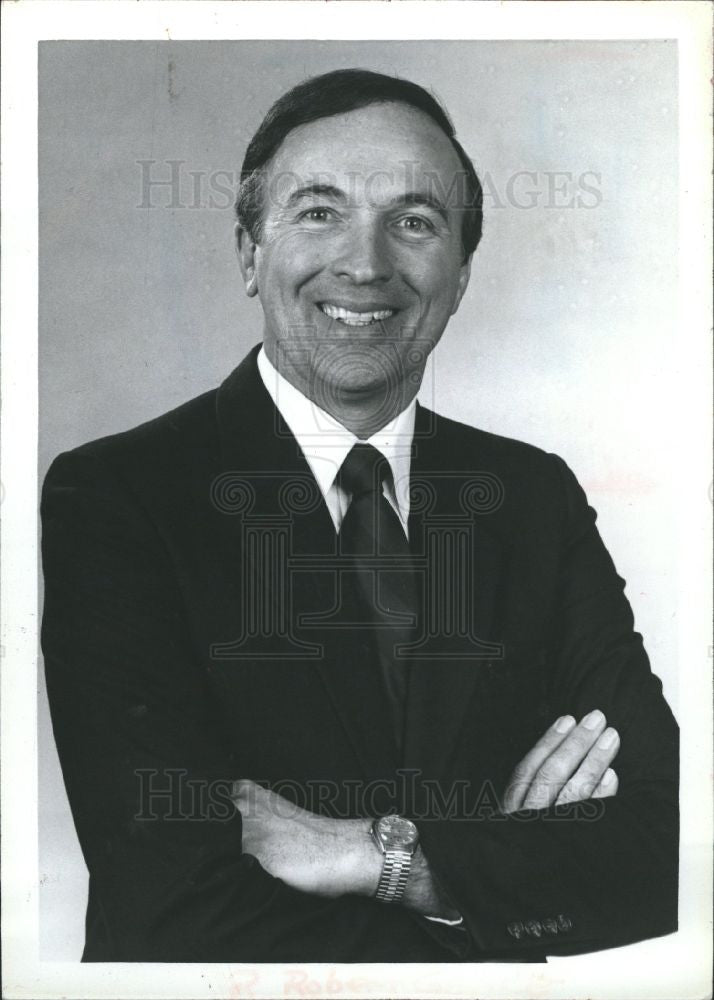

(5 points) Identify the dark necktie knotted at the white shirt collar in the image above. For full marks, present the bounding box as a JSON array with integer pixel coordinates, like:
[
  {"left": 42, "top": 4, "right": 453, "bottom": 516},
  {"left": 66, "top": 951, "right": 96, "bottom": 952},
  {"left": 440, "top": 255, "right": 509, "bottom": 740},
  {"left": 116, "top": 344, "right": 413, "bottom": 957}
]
[{"left": 338, "top": 444, "right": 417, "bottom": 747}]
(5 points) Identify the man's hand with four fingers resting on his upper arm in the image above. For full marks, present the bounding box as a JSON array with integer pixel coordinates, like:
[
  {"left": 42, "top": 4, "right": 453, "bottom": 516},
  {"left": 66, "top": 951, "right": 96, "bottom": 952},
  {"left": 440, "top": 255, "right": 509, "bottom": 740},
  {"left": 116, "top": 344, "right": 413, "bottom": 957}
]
[{"left": 503, "top": 710, "right": 620, "bottom": 813}]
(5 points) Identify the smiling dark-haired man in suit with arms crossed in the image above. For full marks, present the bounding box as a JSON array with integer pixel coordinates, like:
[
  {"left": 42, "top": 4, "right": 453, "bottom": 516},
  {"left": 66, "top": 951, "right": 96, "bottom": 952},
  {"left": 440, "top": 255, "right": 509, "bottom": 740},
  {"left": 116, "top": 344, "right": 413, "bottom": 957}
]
[{"left": 43, "top": 70, "right": 678, "bottom": 962}]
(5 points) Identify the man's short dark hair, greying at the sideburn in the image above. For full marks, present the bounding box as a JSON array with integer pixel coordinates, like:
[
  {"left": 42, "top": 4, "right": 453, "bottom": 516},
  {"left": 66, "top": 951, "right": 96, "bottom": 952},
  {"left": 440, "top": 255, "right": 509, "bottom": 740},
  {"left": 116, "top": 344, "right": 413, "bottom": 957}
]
[{"left": 236, "top": 69, "right": 483, "bottom": 259}]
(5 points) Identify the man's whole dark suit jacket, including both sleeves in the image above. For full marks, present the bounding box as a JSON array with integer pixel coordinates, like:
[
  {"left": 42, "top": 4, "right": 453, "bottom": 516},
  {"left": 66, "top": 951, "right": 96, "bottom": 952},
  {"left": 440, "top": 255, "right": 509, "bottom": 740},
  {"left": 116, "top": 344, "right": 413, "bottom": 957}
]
[{"left": 42, "top": 349, "right": 678, "bottom": 962}]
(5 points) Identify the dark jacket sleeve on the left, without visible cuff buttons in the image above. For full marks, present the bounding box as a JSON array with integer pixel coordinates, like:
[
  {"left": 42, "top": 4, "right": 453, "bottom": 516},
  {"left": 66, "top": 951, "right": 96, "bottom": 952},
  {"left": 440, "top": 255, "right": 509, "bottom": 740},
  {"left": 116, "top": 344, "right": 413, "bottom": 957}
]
[{"left": 42, "top": 449, "right": 452, "bottom": 962}]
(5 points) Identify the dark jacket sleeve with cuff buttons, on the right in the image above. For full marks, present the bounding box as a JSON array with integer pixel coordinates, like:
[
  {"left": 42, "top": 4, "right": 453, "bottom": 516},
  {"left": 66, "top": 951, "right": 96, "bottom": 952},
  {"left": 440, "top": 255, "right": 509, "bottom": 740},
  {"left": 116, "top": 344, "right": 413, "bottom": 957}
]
[{"left": 420, "top": 456, "right": 679, "bottom": 960}]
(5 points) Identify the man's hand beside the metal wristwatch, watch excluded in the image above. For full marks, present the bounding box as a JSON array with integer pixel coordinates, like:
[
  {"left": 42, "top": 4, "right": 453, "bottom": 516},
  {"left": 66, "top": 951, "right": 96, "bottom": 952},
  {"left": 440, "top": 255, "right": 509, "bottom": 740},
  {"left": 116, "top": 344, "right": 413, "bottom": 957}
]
[{"left": 232, "top": 780, "right": 382, "bottom": 896}]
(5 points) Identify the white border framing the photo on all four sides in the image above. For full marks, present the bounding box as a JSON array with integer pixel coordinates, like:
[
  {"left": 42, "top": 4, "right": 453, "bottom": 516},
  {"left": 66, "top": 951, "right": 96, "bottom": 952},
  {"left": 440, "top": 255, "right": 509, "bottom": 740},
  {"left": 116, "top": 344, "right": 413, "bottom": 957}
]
[{"left": 0, "top": 0, "right": 713, "bottom": 1000}]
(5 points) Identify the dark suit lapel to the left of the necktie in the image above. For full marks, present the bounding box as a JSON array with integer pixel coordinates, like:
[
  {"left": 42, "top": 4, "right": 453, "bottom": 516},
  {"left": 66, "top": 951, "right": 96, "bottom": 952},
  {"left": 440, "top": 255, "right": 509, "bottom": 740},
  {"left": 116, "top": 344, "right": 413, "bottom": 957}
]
[{"left": 216, "top": 347, "right": 398, "bottom": 780}]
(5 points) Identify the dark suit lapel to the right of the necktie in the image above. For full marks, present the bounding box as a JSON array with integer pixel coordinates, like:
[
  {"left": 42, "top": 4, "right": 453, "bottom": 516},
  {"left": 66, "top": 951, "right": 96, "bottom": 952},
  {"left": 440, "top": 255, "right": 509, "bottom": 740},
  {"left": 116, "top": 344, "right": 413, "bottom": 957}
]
[{"left": 404, "top": 408, "right": 503, "bottom": 777}]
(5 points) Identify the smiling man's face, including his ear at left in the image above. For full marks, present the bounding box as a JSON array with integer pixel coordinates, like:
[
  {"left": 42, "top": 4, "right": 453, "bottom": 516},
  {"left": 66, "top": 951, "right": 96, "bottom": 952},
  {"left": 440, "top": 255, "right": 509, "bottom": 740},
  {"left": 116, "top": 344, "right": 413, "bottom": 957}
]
[{"left": 240, "top": 104, "right": 469, "bottom": 415}]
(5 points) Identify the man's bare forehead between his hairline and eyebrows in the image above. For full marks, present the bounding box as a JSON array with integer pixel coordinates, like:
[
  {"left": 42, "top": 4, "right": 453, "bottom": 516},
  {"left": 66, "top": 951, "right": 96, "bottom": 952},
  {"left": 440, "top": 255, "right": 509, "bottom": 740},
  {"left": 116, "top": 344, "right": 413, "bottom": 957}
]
[{"left": 268, "top": 103, "right": 463, "bottom": 204}]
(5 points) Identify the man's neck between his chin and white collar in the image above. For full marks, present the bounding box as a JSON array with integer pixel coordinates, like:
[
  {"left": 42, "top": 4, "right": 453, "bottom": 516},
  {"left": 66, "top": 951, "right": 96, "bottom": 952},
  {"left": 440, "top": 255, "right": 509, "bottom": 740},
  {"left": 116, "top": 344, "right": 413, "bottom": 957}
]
[{"left": 264, "top": 342, "right": 419, "bottom": 441}]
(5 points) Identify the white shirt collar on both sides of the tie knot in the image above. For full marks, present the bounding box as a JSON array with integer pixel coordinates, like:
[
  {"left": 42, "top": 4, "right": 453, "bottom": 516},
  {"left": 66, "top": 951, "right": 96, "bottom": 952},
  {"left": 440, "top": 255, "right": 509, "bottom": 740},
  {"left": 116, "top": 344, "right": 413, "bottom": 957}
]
[{"left": 258, "top": 347, "right": 416, "bottom": 523}]
